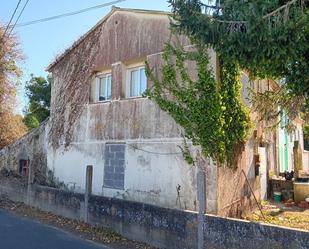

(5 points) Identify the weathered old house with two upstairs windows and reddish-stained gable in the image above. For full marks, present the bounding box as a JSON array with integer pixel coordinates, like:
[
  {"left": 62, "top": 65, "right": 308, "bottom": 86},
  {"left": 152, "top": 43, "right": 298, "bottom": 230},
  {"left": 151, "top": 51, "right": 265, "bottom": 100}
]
[{"left": 0, "top": 7, "right": 306, "bottom": 216}]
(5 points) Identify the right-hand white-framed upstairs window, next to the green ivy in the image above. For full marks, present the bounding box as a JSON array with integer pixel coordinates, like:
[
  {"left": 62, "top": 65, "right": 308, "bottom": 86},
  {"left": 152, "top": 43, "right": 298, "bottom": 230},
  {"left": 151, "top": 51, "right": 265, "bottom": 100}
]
[{"left": 127, "top": 66, "right": 147, "bottom": 98}]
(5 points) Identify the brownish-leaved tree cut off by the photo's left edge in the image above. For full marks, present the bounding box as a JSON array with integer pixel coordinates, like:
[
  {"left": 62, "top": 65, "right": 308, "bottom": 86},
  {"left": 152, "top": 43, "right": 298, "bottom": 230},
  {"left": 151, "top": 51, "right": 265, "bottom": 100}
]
[{"left": 0, "top": 24, "right": 26, "bottom": 149}]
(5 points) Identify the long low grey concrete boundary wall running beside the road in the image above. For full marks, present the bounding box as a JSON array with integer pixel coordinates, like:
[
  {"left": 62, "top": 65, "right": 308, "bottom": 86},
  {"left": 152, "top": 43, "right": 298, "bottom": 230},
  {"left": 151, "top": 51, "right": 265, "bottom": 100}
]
[{"left": 0, "top": 179, "right": 309, "bottom": 249}]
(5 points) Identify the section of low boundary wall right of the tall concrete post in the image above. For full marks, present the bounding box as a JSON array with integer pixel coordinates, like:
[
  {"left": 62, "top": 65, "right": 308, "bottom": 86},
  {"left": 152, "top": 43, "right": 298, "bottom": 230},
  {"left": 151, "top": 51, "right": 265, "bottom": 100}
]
[{"left": 204, "top": 215, "right": 309, "bottom": 249}]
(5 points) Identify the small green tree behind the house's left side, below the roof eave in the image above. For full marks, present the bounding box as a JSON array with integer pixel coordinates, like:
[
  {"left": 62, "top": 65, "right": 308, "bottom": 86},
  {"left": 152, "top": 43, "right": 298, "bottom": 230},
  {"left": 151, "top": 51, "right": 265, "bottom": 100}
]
[{"left": 24, "top": 75, "right": 51, "bottom": 129}]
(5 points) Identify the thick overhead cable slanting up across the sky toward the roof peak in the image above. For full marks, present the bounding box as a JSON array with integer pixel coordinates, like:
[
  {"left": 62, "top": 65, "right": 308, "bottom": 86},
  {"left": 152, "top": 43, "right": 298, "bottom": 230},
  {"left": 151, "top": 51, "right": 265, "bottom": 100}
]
[{"left": 11, "top": 0, "right": 126, "bottom": 28}]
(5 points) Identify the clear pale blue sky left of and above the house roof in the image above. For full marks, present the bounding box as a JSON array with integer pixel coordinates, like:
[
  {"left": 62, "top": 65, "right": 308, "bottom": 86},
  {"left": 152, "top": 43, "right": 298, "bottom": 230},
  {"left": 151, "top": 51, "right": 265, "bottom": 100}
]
[{"left": 0, "top": 0, "right": 170, "bottom": 112}]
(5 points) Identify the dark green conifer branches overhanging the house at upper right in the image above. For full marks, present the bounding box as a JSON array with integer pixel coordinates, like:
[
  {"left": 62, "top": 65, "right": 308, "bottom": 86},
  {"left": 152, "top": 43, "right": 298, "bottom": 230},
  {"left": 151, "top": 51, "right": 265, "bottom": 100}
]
[{"left": 170, "top": 0, "right": 309, "bottom": 124}]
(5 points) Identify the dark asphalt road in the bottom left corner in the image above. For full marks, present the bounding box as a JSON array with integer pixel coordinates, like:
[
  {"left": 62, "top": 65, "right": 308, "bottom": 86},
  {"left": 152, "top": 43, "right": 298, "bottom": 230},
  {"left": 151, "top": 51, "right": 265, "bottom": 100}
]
[{"left": 0, "top": 210, "right": 110, "bottom": 249}]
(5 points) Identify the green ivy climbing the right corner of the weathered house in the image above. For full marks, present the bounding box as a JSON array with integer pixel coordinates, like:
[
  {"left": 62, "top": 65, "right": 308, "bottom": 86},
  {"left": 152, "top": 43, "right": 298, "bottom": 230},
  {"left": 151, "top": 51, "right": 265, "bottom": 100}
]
[{"left": 146, "top": 43, "right": 251, "bottom": 166}]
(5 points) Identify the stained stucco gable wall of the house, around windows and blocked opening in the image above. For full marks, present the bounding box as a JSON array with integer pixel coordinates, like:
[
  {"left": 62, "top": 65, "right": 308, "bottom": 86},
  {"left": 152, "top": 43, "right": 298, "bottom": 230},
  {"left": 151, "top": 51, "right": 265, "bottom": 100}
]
[{"left": 47, "top": 10, "right": 207, "bottom": 210}]
